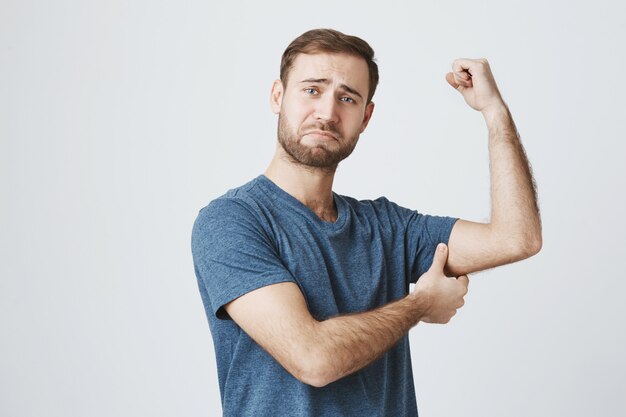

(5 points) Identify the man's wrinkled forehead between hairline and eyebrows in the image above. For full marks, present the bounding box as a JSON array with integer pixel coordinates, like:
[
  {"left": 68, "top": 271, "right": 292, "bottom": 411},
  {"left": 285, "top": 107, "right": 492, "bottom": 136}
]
[{"left": 289, "top": 53, "right": 369, "bottom": 93}]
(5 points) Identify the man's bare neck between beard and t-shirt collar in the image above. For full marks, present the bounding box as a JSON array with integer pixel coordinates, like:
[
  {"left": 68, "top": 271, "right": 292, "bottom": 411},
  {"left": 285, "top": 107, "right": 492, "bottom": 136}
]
[{"left": 265, "top": 143, "right": 337, "bottom": 222}]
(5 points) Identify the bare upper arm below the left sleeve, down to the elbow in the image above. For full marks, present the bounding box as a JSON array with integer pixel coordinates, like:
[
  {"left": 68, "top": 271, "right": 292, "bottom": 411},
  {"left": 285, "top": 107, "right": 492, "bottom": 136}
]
[{"left": 224, "top": 282, "right": 318, "bottom": 380}]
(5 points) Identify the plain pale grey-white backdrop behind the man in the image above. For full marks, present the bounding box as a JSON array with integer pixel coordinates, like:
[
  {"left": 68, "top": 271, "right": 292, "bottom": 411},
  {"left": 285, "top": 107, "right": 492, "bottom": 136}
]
[{"left": 0, "top": 0, "right": 626, "bottom": 417}]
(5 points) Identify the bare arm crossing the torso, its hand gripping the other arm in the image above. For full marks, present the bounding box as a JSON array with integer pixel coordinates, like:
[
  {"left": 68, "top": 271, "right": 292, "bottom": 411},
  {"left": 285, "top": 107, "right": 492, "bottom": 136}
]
[{"left": 225, "top": 244, "right": 468, "bottom": 387}]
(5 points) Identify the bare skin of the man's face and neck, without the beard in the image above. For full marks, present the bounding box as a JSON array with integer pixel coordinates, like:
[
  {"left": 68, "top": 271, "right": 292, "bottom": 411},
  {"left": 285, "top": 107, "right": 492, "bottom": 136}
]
[{"left": 265, "top": 54, "right": 374, "bottom": 222}]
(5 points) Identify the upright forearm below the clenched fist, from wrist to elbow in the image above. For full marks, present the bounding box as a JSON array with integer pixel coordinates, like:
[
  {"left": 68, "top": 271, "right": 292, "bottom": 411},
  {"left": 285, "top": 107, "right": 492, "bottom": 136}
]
[{"left": 483, "top": 103, "right": 541, "bottom": 256}]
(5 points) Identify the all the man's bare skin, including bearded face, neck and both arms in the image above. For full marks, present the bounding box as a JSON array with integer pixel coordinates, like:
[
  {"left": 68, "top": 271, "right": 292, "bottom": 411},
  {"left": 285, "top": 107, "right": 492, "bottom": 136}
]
[{"left": 225, "top": 53, "right": 541, "bottom": 387}]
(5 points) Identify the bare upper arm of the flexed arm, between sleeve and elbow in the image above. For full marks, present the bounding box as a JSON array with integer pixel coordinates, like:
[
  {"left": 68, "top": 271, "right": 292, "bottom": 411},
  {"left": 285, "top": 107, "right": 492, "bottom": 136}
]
[{"left": 445, "top": 219, "right": 520, "bottom": 276}]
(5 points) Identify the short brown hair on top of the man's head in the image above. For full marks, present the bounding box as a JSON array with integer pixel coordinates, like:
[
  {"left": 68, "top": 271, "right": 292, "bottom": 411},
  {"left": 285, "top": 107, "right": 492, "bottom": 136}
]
[{"left": 280, "top": 29, "right": 378, "bottom": 103}]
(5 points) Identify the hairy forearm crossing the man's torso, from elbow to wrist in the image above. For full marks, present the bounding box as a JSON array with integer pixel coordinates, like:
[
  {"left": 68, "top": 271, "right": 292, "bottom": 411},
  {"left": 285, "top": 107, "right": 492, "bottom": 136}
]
[{"left": 304, "top": 291, "right": 427, "bottom": 386}]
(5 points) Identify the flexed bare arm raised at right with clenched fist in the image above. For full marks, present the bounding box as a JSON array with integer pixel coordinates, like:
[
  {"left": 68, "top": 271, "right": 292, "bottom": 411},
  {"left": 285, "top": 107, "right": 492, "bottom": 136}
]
[{"left": 446, "top": 59, "right": 542, "bottom": 275}]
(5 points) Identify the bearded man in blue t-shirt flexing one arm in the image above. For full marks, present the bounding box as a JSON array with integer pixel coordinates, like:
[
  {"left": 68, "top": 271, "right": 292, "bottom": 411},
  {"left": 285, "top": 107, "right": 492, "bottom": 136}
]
[{"left": 192, "top": 29, "right": 541, "bottom": 417}]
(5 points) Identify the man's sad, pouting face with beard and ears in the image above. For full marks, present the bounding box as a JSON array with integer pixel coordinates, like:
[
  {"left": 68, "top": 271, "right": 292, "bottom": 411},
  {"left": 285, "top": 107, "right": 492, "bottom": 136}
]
[{"left": 271, "top": 53, "right": 374, "bottom": 170}]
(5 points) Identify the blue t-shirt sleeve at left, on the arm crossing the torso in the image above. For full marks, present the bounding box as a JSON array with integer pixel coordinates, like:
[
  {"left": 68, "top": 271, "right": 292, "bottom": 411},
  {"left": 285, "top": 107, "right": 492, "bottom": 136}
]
[{"left": 191, "top": 198, "right": 295, "bottom": 319}]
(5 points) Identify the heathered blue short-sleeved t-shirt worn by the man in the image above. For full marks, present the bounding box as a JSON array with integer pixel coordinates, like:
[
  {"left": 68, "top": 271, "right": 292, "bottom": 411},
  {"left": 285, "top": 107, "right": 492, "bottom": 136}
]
[{"left": 192, "top": 175, "right": 456, "bottom": 417}]
